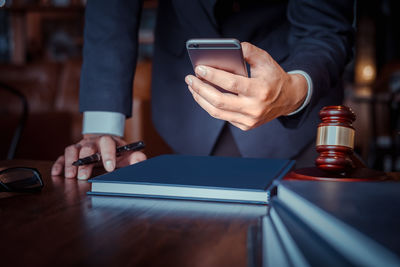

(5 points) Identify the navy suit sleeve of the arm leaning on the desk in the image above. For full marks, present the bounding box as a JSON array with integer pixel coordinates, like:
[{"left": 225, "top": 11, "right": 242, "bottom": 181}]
[{"left": 80, "top": 0, "right": 142, "bottom": 117}]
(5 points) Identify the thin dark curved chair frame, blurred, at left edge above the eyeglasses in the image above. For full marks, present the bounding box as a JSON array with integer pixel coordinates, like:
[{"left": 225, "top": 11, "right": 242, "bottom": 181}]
[{"left": 0, "top": 82, "right": 29, "bottom": 159}]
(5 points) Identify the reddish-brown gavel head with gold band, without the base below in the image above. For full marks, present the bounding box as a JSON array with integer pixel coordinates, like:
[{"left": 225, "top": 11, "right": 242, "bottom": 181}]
[{"left": 315, "top": 106, "right": 356, "bottom": 173}]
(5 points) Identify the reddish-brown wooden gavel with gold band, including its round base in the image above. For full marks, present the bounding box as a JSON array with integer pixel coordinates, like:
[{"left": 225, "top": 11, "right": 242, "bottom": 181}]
[{"left": 286, "top": 106, "right": 387, "bottom": 181}]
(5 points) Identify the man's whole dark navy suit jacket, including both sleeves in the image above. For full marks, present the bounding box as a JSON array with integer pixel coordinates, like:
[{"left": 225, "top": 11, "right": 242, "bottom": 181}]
[{"left": 80, "top": 0, "right": 354, "bottom": 158}]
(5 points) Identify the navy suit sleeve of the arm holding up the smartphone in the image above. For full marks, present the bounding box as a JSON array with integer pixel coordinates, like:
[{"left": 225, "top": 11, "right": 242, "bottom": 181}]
[{"left": 281, "top": 0, "right": 354, "bottom": 127}]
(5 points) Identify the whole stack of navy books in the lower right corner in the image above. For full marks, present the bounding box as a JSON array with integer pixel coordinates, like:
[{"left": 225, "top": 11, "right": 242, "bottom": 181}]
[{"left": 259, "top": 181, "right": 400, "bottom": 266}]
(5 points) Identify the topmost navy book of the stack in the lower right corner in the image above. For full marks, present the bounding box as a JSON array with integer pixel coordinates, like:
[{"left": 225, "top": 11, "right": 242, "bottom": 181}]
[{"left": 277, "top": 181, "right": 400, "bottom": 266}]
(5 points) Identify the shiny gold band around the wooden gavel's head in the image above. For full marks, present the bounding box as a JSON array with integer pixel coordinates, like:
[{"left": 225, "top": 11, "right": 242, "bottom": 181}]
[{"left": 317, "top": 126, "right": 354, "bottom": 148}]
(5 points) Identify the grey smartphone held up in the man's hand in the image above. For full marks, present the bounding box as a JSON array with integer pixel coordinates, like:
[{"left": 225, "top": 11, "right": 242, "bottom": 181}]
[{"left": 186, "top": 38, "right": 248, "bottom": 77}]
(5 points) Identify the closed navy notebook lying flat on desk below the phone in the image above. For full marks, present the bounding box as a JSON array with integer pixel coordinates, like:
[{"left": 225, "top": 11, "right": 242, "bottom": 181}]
[{"left": 88, "top": 155, "right": 294, "bottom": 204}]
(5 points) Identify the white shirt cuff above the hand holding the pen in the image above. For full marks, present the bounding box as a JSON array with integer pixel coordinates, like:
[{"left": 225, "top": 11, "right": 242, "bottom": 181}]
[{"left": 82, "top": 111, "right": 125, "bottom": 137}]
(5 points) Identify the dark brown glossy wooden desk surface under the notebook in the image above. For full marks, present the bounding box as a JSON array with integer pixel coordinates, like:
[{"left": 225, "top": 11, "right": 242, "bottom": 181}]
[{"left": 0, "top": 161, "right": 266, "bottom": 266}]
